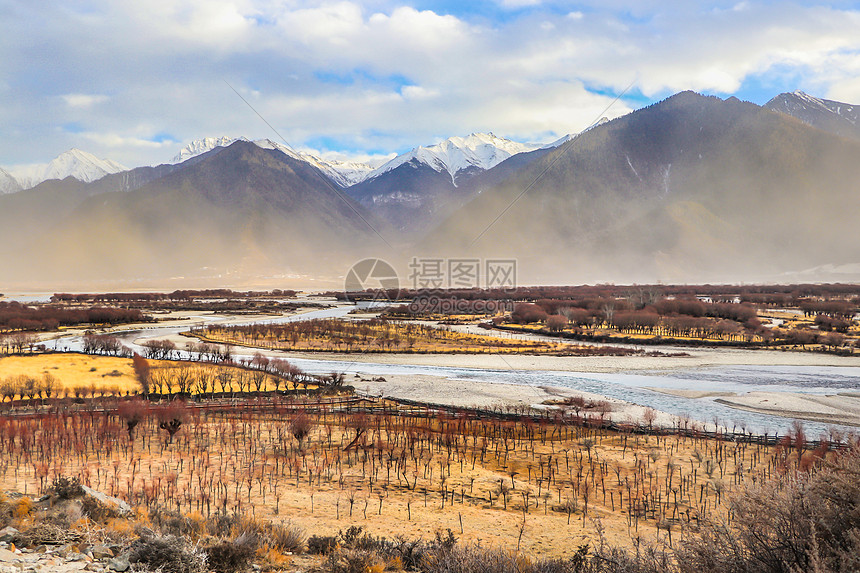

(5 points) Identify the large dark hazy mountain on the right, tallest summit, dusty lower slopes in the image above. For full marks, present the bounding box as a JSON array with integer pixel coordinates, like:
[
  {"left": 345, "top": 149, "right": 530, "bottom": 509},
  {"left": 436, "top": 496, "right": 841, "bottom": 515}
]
[{"left": 423, "top": 92, "right": 860, "bottom": 282}]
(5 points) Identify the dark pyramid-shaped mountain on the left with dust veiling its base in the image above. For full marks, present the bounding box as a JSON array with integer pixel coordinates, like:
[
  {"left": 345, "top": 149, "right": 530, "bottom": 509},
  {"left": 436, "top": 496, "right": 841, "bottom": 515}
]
[{"left": 2, "top": 142, "right": 386, "bottom": 281}]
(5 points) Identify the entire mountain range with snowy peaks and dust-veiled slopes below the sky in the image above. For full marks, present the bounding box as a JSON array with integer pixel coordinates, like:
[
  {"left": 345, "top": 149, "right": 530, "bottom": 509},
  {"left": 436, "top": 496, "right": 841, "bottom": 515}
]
[{"left": 0, "top": 92, "right": 860, "bottom": 288}]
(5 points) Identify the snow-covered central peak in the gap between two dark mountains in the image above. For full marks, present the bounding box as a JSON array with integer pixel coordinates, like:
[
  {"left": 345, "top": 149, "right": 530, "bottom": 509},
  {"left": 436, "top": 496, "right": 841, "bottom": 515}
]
[{"left": 367, "top": 133, "right": 540, "bottom": 183}]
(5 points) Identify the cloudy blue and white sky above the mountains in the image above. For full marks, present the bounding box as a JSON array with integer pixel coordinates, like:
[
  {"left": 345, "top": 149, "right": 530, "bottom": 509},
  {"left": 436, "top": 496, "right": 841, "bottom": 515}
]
[{"left": 0, "top": 0, "right": 860, "bottom": 167}]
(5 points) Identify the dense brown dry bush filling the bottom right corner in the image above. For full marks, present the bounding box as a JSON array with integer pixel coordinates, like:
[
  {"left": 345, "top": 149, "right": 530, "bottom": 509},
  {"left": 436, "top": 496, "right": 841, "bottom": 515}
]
[{"left": 678, "top": 446, "right": 860, "bottom": 573}]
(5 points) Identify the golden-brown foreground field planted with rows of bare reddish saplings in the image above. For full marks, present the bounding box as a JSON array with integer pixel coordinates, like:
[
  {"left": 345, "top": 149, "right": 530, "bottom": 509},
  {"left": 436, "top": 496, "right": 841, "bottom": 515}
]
[{"left": 0, "top": 397, "right": 826, "bottom": 556}]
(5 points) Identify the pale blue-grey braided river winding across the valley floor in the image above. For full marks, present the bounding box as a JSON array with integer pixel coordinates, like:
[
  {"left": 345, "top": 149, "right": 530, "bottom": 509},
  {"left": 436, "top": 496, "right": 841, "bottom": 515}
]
[{"left": 49, "top": 306, "right": 860, "bottom": 437}]
